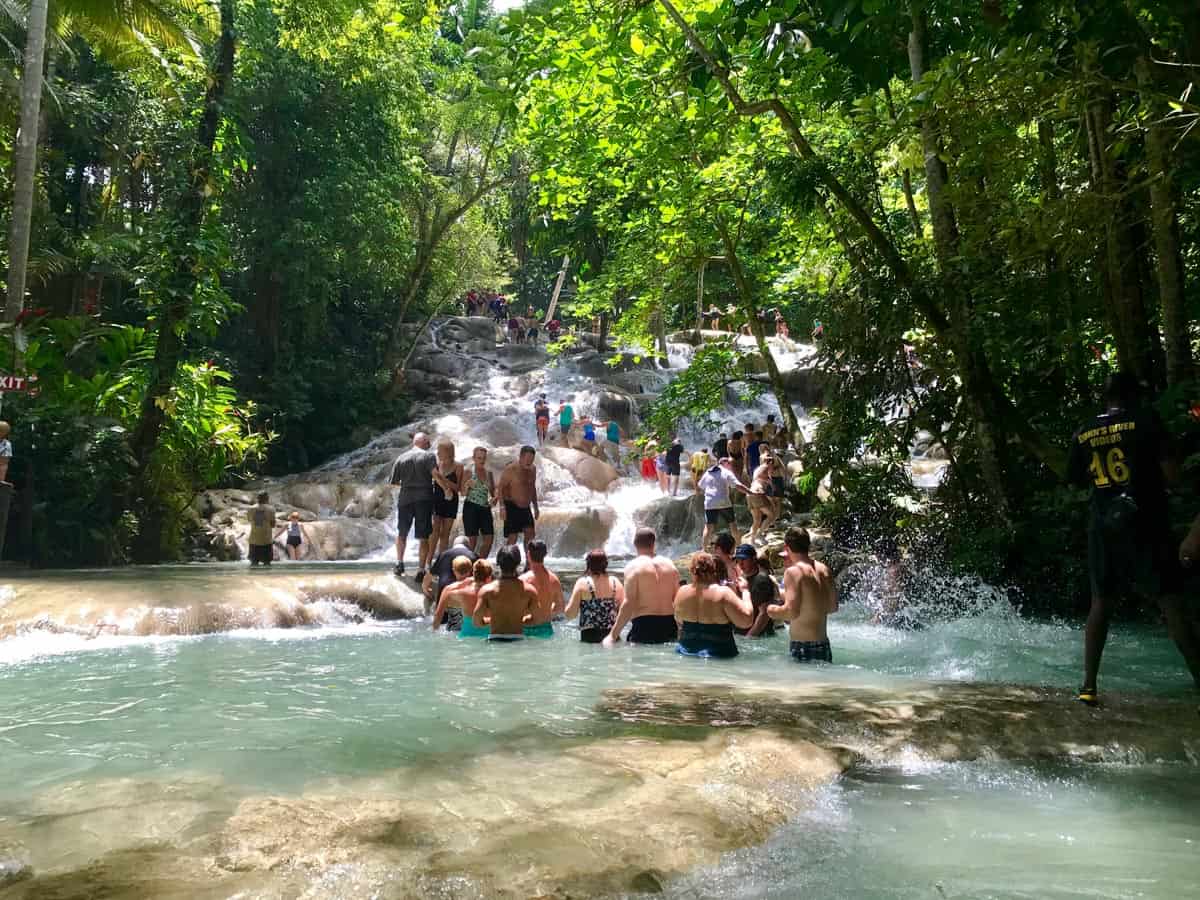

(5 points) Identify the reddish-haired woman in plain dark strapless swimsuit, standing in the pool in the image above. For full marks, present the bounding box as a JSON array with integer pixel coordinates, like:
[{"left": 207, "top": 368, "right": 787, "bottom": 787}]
[{"left": 674, "top": 551, "right": 754, "bottom": 659}]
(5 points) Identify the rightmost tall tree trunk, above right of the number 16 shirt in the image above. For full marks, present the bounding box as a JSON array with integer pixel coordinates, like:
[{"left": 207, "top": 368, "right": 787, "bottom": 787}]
[{"left": 1138, "top": 56, "right": 1194, "bottom": 385}]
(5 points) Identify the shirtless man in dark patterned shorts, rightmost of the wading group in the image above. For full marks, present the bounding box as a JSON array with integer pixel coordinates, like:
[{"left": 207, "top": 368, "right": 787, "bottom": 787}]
[{"left": 767, "top": 528, "right": 838, "bottom": 662}]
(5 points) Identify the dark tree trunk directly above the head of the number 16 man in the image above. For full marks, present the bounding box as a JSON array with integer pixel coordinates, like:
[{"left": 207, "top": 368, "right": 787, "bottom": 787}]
[{"left": 1086, "top": 89, "right": 1163, "bottom": 388}]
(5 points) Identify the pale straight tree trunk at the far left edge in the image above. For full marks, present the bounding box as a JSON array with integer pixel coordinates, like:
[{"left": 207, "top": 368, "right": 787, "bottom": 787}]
[{"left": 4, "top": 0, "right": 49, "bottom": 322}]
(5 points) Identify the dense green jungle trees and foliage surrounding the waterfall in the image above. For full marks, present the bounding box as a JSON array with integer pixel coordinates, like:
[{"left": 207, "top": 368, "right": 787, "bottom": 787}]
[{"left": 0, "top": 0, "right": 1200, "bottom": 607}]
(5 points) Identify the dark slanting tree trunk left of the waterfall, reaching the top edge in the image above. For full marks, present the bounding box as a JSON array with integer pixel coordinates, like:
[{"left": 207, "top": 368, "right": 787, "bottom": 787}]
[{"left": 130, "top": 0, "right": 235, "bottom": 518}]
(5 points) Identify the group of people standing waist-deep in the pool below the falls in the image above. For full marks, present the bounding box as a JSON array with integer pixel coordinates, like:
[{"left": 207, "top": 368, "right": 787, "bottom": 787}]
[{"left": 426, "top": 520, "right": 838, "bottom": 662}]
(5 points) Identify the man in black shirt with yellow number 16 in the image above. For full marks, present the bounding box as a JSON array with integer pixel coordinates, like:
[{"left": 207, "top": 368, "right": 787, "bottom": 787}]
[{"left": 1069, "top": 374, "right": 1200, "bottom": 706}]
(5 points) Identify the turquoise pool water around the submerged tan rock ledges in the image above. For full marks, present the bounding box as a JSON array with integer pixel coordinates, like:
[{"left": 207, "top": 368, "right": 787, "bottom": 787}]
[{"left": 0, "top": 569, "right": 1200, "bottom": 898}]
